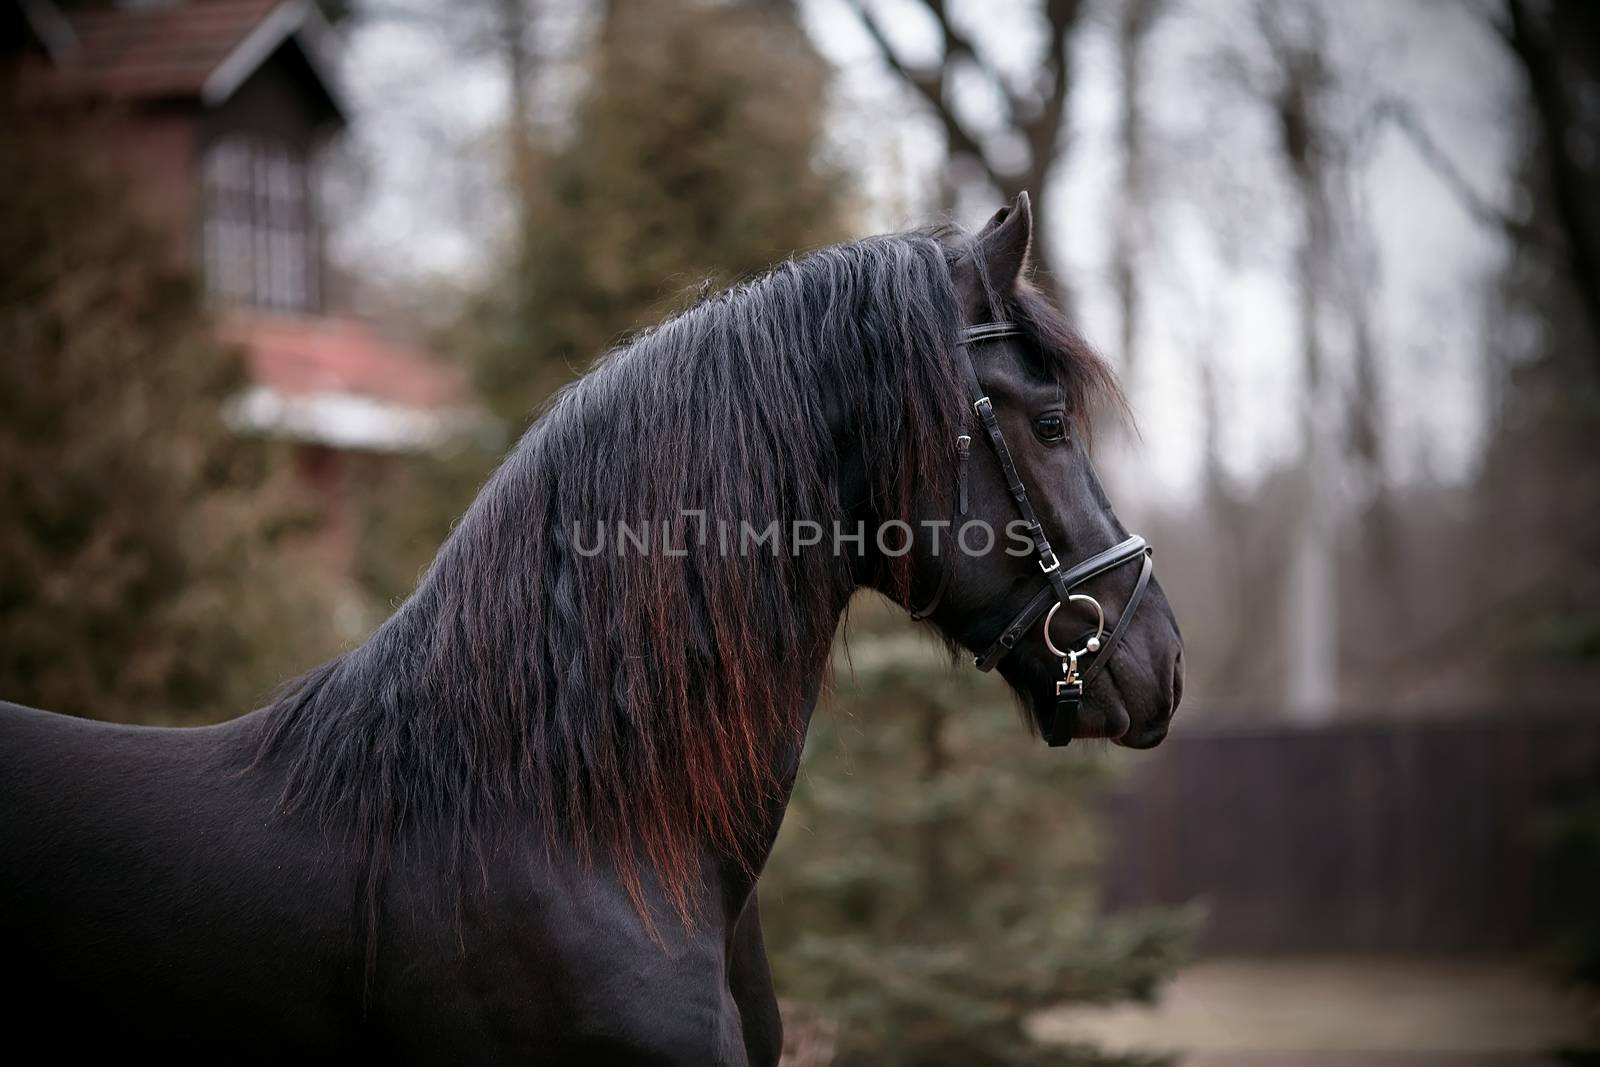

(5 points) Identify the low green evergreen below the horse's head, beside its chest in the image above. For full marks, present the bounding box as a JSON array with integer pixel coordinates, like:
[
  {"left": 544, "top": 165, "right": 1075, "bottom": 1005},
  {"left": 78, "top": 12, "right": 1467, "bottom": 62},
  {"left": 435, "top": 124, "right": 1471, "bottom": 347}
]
[{"left": 762, "top": 611, "right": 1194, "bottom": 1067}]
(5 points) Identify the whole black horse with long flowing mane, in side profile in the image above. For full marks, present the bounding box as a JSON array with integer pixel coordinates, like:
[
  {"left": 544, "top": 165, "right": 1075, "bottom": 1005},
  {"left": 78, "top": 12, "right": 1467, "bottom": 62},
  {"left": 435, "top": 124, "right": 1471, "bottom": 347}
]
[{"left": 0, "top": 197, "right": 1182, "bottom": 1065}]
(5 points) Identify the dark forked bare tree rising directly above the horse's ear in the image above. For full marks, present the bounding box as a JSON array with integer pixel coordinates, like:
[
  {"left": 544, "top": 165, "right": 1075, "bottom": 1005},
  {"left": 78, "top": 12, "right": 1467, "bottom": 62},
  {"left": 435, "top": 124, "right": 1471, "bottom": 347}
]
[{"left": 850, "top": 0, "right": 1085, "bottom": 299}]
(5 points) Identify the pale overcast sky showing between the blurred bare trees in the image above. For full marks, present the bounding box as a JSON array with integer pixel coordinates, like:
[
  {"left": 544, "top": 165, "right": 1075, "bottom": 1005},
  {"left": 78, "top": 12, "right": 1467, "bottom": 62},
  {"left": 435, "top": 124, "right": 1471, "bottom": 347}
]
[{"left": 331, "top": 0, "right": 1518, "bottom": 499}]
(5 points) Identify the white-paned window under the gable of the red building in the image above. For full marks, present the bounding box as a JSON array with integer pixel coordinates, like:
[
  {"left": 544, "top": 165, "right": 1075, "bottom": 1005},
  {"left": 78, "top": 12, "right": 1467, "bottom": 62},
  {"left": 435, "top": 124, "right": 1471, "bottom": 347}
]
[{"left": 205, "top": 136, "right": 317, "bottom": 310}]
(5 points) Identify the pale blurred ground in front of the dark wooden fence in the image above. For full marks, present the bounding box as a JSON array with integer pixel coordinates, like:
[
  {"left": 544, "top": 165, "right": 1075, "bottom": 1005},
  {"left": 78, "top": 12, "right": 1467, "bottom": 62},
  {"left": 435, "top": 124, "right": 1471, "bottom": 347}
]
[{"left": 1032, "top": 957, "right": 1594, "bottom": 1067}]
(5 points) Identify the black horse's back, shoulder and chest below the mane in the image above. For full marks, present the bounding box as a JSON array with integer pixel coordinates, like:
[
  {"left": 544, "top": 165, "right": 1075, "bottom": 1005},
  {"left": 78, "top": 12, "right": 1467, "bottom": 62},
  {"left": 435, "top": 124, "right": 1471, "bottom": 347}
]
[{"left": 0, "top": 702, "right": 779, "bottom": 1064}]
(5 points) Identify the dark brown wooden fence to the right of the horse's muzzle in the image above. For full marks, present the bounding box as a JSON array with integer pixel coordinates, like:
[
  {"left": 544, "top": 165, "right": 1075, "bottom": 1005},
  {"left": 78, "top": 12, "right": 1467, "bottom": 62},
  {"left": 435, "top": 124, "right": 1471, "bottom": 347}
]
[{"left": 1102, "top": 709, "right": 1600, "bottom": 953}]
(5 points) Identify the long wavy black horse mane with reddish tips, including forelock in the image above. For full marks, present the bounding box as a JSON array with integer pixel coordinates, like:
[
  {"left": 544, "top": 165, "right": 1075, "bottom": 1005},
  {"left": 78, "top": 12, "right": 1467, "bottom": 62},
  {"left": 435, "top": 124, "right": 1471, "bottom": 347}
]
[{"left": 258, "top": 234, "right": 1114, "bottom": 920}]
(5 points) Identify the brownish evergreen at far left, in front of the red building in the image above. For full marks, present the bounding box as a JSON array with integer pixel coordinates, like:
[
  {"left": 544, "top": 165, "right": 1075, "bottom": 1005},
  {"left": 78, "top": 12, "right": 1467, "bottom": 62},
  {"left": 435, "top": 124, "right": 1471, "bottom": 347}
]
[{"left": 0, "top": 101, "right": 337, "bottom": 721}]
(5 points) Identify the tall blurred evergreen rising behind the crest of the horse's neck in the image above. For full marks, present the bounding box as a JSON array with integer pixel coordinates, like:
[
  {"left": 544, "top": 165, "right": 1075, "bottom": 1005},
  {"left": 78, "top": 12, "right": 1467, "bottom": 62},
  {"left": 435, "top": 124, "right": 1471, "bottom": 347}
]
[{"left": 470, "top": 0, "right": 846, "bottom": 424}]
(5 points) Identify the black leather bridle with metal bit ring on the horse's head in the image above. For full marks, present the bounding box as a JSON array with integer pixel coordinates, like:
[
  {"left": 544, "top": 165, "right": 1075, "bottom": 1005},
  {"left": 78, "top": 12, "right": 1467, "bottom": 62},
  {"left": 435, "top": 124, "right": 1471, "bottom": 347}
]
[{"left": 910, "top": 322, "right": 1152, "bottom": 747}]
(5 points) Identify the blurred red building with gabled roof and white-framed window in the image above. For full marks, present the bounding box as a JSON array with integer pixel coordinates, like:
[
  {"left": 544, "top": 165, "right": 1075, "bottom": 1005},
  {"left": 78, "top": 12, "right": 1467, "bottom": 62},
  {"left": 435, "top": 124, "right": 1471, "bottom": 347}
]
[{"left": 0, "top": 0, "right": 474, "bottom": 579}]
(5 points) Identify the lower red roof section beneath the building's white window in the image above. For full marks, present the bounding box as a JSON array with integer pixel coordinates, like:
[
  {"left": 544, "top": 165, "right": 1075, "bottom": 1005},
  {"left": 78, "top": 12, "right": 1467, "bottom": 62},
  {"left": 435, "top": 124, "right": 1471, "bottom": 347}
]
[{"left": 224, "top": 314, "right": 470, "bottom": 410}]
